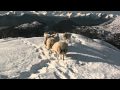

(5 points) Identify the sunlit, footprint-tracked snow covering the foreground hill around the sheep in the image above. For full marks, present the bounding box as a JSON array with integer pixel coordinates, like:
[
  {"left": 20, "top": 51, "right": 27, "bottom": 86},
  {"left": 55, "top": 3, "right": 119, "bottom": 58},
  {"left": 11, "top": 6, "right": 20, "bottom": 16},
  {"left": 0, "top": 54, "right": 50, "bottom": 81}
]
[{"left": 0, "top": 34, "right": 120, "bottom": 79}]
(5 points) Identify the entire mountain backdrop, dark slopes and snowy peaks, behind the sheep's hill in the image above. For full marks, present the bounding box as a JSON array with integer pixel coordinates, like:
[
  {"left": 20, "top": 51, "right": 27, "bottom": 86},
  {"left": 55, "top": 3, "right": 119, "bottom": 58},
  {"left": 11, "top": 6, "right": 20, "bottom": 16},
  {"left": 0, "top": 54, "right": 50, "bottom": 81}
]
[{"left": 0, "top": 11, "right": 119, "bottom": 47}]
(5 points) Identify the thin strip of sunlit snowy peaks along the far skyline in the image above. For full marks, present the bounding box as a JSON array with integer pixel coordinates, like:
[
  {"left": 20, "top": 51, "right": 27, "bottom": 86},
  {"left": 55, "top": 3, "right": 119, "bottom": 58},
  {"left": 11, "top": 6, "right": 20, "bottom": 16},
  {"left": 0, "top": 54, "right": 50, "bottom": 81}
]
[{"left": 0, "top": 11, "right": 115, "bottom": 19}]
